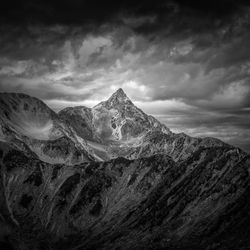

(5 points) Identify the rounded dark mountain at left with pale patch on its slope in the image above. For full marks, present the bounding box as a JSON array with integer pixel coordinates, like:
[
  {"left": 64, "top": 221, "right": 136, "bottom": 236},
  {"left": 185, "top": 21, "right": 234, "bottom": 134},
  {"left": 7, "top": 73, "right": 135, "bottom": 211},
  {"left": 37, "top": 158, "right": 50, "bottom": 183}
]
[{"left": 0, "top": 93, "right": 95, "bottom": 164}]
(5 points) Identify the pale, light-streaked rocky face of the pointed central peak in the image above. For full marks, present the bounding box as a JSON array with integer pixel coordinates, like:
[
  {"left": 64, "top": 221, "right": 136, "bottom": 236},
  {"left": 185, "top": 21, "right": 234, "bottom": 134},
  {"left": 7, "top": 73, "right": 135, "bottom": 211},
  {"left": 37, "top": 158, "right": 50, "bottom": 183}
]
[{"left": 93, "top": 89, "right": 171, "bottom": 142}]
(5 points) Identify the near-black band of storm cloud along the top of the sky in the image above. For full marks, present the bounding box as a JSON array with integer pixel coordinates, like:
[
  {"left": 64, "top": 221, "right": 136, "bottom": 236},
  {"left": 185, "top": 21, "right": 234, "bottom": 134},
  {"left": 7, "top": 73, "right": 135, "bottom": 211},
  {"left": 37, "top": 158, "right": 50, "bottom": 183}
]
[{"left": 0, "top": 0, "right": 249, "bottom": 33}]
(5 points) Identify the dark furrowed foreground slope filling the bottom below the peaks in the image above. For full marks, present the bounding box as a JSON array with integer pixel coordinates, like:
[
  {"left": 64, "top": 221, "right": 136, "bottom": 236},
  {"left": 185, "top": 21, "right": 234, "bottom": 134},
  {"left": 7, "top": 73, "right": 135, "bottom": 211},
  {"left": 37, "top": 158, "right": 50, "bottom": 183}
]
[{"left": 0, "top": 143, "right": 250, "bottom": 249}]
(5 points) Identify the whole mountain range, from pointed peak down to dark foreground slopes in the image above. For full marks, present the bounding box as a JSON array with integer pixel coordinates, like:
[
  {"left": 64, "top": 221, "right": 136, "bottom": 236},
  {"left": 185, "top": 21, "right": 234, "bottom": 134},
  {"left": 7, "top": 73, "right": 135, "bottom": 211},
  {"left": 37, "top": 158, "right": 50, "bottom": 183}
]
[{"left": 0, "top": 89, "right": 250, "bottom": 250}]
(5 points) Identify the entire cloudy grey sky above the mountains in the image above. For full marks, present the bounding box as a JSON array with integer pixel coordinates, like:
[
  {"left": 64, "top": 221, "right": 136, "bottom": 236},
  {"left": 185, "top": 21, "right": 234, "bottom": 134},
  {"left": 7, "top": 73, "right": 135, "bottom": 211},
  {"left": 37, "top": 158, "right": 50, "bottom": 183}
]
[{"left": 0, "top": 0, "right": 250, "bottom": 152}]
